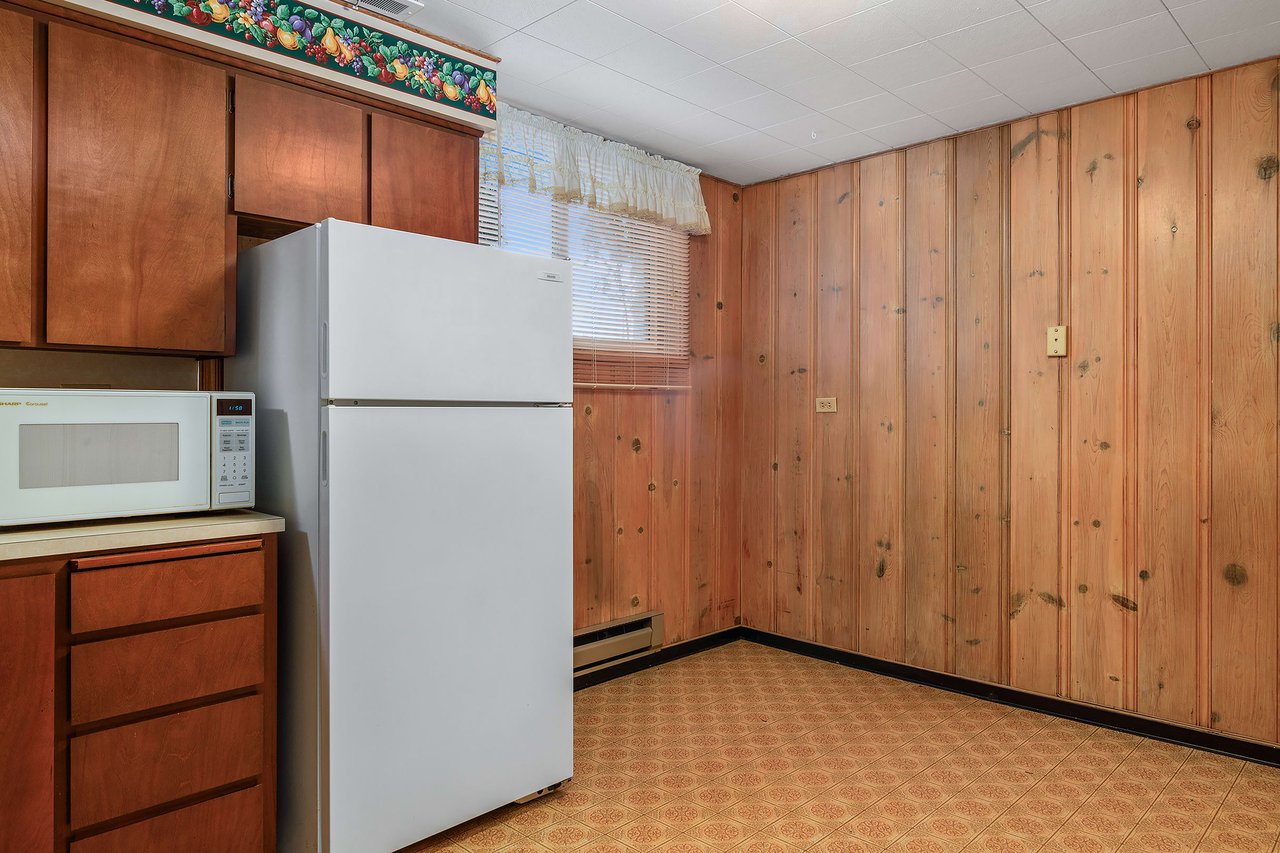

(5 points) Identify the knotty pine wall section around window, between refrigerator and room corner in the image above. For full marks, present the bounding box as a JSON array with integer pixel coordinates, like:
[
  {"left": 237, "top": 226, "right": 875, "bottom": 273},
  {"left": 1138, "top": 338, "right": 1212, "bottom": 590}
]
[{"left": 573, "top": 178, "right": 749, "bottom": 643}]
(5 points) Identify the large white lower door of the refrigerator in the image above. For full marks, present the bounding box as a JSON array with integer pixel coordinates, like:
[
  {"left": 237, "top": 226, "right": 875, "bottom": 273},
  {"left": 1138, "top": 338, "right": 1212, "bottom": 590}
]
[{"left": 321, "top": 406, "right": 572, "bottom": 853}]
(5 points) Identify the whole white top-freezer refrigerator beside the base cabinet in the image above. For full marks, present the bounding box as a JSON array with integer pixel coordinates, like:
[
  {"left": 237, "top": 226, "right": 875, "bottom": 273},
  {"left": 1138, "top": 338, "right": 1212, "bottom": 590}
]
[{"left": 225, "top": 219, "right": 572, "bottom": 853}]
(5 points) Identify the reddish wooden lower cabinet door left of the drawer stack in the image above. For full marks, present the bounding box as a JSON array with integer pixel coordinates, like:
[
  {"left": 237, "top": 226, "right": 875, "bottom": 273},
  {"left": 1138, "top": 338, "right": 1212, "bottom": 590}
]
[{"left": 0, "top": 575, "right": 58, "bottom": 853}]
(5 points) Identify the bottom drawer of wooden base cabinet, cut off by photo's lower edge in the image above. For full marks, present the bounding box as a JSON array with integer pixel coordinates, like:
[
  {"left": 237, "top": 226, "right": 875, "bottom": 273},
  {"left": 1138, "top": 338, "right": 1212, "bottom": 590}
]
[{"left": 72, "top": 785, "right": 262, "bottom": 853}]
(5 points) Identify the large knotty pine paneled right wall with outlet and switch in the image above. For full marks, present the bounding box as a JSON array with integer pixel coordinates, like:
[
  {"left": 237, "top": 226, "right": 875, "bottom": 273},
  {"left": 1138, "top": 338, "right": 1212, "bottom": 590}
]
[{"left": 737, "top": 60, "right": 1280, "bottom": 742}]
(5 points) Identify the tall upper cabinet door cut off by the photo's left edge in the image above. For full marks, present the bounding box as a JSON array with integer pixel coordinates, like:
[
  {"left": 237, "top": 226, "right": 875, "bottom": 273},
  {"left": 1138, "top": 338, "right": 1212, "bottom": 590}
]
[{"left": 0, "top": 10, "right": 36, "bottom": 341}]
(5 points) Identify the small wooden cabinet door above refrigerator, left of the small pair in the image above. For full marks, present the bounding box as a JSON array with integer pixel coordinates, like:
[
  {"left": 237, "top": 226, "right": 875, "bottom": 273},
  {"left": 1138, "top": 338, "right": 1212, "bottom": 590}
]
[{"left": 236, "top": 77, "right": 365, "bottom": 223}]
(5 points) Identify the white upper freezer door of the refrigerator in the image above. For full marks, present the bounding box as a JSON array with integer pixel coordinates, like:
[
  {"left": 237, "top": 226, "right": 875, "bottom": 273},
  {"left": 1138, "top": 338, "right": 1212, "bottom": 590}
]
[{"left": 320, "top": 219, "right": 573, "bottom": 402}]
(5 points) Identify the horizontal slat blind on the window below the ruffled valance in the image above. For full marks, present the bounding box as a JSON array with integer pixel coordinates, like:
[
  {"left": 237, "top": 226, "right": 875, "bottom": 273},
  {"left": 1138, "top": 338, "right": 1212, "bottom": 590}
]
[{"left": 480, "top": 122, "right": 689, "bottom": 388}]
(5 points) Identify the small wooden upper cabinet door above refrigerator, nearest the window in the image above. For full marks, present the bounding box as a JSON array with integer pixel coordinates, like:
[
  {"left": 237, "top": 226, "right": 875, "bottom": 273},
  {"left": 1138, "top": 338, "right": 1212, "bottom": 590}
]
[{"left": 370, "top": 113, "right": 480, "bottom": 243}]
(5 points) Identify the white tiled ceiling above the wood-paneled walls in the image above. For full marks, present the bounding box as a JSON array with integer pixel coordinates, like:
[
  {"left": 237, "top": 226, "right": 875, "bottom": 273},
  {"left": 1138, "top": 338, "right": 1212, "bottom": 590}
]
[{"left": 411, "top": 0, "right": 1280, "bottom": 183}]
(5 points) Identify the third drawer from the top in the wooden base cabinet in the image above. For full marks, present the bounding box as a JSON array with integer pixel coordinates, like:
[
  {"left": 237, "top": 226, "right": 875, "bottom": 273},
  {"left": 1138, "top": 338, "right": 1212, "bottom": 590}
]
[{"left": 70, "top": 695, "right": 262, "bottom": 830}]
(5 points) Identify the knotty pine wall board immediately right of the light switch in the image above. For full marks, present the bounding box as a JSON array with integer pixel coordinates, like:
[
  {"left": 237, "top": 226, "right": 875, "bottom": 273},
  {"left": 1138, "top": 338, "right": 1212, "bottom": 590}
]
[{"left": 1064, "top": 97, "right": 1135, "bottom": 708}]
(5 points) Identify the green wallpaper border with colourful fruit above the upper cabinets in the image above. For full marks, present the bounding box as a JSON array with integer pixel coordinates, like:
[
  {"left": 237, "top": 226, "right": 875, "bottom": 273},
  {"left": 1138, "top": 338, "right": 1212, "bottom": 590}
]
[{"left": 109, "top": 0, "right": 498, "bottom": 119}]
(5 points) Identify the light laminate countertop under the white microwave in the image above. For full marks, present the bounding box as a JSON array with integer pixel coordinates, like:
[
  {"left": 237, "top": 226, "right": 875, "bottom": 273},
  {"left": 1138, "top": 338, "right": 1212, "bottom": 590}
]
[{"left": 0, "top": 510, "right": 284, "bottom": 562}]
